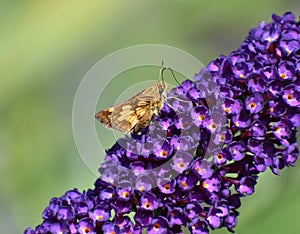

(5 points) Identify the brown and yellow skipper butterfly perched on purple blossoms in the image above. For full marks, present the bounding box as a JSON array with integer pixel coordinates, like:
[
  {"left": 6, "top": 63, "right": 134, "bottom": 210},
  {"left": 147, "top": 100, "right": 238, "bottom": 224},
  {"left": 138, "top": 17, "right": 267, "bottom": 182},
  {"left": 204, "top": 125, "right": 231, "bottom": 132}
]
[{"left": 95, "top": 64, "right": 177, "bottom": 133}]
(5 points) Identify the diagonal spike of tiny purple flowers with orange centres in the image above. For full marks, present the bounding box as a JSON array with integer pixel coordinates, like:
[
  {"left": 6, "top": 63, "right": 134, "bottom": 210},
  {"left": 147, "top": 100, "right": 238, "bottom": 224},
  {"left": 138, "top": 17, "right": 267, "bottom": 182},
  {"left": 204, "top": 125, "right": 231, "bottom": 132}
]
[{"left": 25, "top": 12, "right": 300, "bottom": 234}]
